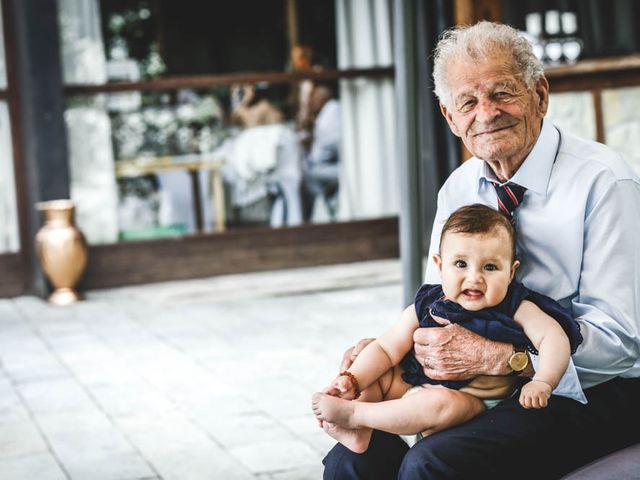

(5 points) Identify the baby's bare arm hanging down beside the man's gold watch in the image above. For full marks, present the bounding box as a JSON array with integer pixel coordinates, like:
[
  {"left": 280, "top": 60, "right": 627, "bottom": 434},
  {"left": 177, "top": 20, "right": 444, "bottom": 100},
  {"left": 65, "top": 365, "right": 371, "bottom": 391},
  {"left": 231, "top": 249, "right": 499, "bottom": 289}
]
[{"left": 514, "top": 300, "right": 571, "bottom": 408}]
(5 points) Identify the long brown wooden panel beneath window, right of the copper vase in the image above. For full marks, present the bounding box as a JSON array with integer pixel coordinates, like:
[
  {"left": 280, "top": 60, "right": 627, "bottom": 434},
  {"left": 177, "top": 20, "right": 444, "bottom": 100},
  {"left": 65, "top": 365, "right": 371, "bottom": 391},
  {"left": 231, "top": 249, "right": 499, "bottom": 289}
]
[{"left": 80, "top": 217, "right": 399, "bottom": 290}]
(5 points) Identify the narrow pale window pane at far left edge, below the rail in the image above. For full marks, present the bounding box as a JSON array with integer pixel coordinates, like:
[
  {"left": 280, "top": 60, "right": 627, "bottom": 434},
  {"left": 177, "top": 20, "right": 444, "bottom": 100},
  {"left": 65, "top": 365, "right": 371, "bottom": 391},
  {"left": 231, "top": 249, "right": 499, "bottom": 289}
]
[{"left": 0, "top": 102, "right": 20, "bottom": 253}]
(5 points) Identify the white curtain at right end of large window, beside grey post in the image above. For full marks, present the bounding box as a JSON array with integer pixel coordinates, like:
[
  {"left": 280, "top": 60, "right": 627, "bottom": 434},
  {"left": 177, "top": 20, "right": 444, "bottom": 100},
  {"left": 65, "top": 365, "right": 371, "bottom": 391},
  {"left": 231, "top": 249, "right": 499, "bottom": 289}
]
[{"left": 336, "top": 0, "right": 399, "bottom": 220}]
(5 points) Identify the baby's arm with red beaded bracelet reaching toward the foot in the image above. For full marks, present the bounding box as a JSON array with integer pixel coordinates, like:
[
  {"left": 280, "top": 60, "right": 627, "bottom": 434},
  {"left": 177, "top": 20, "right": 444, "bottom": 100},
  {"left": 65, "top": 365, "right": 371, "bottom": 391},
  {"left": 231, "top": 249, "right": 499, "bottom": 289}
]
[{"left": 325, "top": 305, "right": 419, "bottom": 399}]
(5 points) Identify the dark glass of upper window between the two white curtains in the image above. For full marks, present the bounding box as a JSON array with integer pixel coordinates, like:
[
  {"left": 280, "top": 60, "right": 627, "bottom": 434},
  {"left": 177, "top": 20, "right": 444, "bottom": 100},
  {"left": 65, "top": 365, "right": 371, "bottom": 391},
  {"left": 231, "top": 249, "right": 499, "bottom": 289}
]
[{"left": 100, "top": 0, "right": 335, "bottom": 80}]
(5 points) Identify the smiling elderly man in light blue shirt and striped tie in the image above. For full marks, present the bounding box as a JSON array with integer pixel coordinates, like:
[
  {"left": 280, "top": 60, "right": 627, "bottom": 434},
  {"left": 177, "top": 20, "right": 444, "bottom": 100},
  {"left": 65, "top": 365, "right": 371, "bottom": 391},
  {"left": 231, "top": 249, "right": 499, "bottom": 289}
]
[{"left": 324, "top": 22, "right": 640, "bottom": 480}]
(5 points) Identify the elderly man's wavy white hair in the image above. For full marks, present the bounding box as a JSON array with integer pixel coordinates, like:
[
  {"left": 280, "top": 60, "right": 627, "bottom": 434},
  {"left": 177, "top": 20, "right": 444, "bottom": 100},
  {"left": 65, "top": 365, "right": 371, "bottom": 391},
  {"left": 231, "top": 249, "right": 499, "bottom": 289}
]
[{"left": 433, "top": 21, "right": 544, "bottom": 108}]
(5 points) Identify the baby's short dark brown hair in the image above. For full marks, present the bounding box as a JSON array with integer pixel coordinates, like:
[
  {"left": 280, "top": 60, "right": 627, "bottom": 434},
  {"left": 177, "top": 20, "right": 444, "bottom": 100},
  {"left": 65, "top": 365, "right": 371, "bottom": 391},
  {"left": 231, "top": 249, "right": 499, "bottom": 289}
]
[{"left": 439, "top": 203, "right": 516, "bottom": 260}]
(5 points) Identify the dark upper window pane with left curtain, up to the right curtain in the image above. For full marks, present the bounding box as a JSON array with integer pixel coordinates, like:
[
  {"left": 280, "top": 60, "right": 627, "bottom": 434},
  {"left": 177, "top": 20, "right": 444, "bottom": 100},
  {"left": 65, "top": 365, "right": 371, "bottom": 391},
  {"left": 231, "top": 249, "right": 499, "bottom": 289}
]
[{"left": 58, "top": 0, "right": 336, "bottom": 83}]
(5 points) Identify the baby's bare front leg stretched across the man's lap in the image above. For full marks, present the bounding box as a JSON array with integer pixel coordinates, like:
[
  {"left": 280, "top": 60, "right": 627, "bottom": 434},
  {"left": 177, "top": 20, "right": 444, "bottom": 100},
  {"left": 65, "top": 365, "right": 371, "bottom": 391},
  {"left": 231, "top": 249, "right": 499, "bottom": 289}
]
[{"left": 312, "top": 385, "right": 485, "bottom": 435}]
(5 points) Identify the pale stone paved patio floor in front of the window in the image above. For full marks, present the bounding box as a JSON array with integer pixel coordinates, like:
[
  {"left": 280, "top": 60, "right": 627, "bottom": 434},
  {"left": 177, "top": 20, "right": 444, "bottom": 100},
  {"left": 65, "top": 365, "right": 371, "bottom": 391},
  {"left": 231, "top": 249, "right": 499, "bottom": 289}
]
[{"left": 0, "top": 260, "right": 402, "bottom": 480}]
